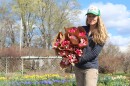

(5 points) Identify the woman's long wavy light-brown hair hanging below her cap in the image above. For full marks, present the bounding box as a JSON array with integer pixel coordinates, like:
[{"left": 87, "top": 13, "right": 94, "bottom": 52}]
[{"left": 86, "top": 16, "right": 108, "bottom": 44}]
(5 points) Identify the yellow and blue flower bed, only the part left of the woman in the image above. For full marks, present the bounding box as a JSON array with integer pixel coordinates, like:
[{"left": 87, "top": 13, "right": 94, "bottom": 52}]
[{"left": 0, "top": 74, "right": 75, "bottom": 86}]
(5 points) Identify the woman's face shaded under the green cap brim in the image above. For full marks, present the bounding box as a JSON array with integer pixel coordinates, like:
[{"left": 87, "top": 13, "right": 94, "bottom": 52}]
[{"left": 87, "top": 14, "right": 98, "bottom": 26}]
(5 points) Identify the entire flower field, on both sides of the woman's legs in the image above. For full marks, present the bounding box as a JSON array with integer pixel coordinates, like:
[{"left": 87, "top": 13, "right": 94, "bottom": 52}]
[{"left": 0, "top": 74, "right": 130, "bottom": 86}]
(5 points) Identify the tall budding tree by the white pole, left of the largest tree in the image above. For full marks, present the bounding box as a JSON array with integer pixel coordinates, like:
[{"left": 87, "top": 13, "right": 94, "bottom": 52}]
[{"left": 12, "top": 0, "right": 35, "bottom": 47}]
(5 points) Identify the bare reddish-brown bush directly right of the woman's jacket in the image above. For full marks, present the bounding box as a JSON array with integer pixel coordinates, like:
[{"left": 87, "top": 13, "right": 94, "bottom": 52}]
[{"left": 99, "top": 43, "right": 124, "bottom": 73}]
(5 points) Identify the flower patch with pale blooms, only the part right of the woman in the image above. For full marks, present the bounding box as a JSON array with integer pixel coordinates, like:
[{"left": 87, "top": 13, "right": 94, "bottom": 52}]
[{"left": 98, "top": 74, "right": 130, "bottom": 86}]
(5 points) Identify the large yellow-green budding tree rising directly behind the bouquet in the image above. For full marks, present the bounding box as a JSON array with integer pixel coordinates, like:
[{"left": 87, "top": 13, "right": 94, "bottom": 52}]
[{"left": 34, "top": 0, "right": 78, "bottom": 49}]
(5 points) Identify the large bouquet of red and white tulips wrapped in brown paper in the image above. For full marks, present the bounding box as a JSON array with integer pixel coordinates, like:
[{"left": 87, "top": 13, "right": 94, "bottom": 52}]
[{"left": 53, "top": 27, "right": 88, "bottom": 68}]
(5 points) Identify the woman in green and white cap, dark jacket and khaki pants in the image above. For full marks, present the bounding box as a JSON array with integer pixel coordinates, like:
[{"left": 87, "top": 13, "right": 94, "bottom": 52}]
[{"left": 74, "top": 6, "right": 108, "bottom": 86}]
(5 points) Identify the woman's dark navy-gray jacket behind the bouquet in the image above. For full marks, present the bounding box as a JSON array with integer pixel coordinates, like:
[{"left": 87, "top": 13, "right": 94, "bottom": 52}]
[{"left": 75, "top": 26, "right": 104, "bottom": 69}]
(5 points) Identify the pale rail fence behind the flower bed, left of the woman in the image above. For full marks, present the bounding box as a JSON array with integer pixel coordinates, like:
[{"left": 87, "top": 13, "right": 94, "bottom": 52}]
[{"left": 0, "top": 56, "right": 71, "bottom": 74}]
